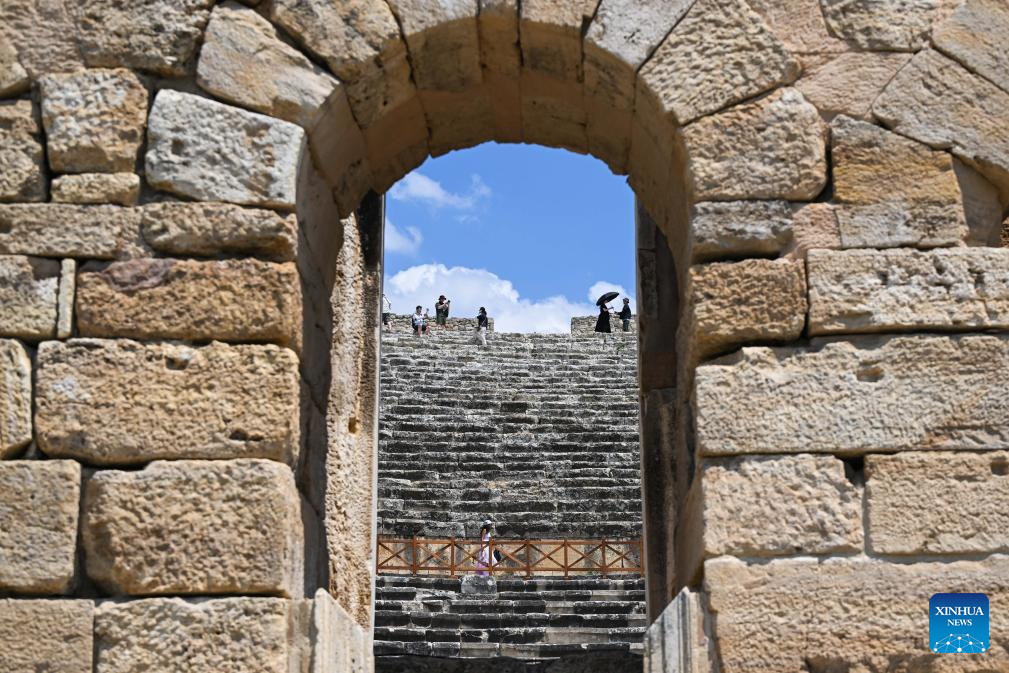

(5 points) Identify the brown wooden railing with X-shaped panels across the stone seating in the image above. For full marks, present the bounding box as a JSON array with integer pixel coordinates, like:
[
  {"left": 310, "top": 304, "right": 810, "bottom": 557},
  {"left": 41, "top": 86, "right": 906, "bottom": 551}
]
[{"left": 375, "top": 537, "right": 642, "bottom": 577}]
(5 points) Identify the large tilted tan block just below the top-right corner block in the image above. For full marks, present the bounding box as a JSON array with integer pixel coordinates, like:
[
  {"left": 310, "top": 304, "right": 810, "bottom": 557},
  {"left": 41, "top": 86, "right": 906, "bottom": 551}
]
[{"left": 873, "top": 49, "right": 1009, "bottom": 194}]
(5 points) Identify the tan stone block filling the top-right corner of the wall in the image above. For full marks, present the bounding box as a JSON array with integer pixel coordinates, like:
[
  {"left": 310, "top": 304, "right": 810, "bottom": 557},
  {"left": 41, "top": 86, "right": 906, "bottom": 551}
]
[{"left": 932, "top": 0, "right": 1009, "bottom": 91}]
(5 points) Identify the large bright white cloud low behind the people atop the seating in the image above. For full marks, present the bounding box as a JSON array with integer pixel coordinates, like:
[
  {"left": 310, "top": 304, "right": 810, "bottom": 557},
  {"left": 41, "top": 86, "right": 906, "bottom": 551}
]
[{"left": 385, "top": 264, "right": 629, "bottom": 333}]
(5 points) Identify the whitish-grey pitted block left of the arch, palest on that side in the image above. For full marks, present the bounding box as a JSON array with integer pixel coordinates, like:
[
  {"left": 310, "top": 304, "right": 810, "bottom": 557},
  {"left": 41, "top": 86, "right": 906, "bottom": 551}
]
[{"left": 146, "top": 89, "right": 305, "bottom": 209}]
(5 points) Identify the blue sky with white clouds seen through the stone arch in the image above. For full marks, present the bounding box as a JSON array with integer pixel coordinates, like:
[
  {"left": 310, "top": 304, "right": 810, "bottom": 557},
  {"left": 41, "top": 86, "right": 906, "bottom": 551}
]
[{"left": 385, "top": 143, "right": 635, "bottom": 332}]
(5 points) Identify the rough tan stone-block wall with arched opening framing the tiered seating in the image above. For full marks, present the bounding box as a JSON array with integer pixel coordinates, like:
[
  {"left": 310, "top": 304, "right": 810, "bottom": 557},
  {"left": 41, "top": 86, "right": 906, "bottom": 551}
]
[{"left": 0, "top": 0, "right": 1009, "bottom": 673}]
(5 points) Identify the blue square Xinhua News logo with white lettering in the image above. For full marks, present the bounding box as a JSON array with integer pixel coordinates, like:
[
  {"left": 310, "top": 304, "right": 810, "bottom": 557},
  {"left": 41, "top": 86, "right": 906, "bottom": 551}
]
[{"left": 928, "top": 593, "right": 988, "bottom": 654}]
